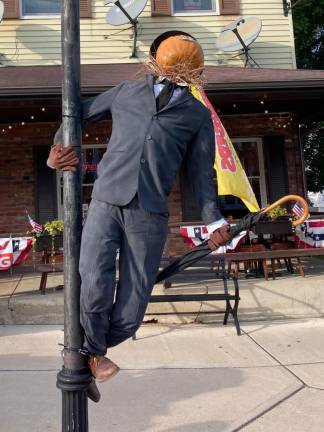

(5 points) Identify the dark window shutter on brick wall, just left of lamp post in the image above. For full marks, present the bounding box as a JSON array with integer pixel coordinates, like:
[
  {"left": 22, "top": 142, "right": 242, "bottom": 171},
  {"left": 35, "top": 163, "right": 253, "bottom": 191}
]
[{"left": 34, "top": 146, "right": 57, "bottom": 223}]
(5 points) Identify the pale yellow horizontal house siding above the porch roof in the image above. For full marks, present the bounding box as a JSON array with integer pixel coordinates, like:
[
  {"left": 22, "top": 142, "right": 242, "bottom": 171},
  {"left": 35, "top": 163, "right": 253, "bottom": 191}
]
[{"left": 0, "top": 0, "right": 296, "bottom": 69}]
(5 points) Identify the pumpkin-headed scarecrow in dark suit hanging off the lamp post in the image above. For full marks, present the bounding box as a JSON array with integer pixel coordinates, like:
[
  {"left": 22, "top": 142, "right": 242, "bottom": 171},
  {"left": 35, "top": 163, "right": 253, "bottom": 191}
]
[{"left": 48, "top": 31, "right": 231, "bottom": 382}]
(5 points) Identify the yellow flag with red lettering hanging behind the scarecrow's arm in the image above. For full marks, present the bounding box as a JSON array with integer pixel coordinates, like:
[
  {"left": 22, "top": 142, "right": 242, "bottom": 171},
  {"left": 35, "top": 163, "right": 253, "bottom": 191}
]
[{"left": 190, "top": 85, "right": 260, "bottom": 211}]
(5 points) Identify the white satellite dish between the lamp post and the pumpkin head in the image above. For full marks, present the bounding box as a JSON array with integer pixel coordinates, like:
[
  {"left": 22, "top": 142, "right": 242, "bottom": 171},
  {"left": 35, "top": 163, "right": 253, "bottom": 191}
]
[{"left": 104, "top": 0, "right": 147, "bottom": 57}]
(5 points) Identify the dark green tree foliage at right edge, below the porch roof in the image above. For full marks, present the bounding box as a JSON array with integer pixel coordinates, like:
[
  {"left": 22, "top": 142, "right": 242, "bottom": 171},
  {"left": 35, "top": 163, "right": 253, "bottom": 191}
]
[{"left": 303, "top": 121, "right": 324, "bottom": 192}]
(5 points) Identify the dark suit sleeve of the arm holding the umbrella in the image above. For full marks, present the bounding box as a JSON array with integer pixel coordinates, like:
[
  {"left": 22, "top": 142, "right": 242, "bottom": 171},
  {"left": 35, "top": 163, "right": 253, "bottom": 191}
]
[{"left": 186, "top": 113, "right": 223, "bottom": 225}]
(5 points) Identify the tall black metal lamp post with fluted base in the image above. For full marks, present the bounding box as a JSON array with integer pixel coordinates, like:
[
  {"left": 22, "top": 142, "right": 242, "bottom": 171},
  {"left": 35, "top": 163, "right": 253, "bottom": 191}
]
[{"left": 57, "top": 0, "right": 100, "bottom": 432}]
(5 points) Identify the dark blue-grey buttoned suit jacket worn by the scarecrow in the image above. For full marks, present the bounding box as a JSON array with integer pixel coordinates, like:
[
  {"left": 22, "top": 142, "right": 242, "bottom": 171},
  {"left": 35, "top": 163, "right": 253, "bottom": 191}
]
[{"left": 54, "top": 75, "right": 222, "bottom": 224}]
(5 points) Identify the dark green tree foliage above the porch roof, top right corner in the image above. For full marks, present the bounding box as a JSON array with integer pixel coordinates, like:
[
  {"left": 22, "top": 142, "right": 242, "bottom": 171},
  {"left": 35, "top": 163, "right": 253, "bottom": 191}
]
[{"left": 292, "top": 0, "right": 324, "bottom": 69}]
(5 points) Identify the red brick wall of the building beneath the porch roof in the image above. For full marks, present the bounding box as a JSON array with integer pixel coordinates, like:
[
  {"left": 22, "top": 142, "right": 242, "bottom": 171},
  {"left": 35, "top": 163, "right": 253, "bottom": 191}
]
[{"left": 0, "top": 116, "right": 304, "bottom": 255}]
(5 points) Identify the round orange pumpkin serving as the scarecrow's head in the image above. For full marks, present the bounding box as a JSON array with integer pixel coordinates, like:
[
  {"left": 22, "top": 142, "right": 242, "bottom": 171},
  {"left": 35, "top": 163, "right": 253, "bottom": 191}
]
[{"left": 155, "top": 35, "right": 204, "bottom": 72}]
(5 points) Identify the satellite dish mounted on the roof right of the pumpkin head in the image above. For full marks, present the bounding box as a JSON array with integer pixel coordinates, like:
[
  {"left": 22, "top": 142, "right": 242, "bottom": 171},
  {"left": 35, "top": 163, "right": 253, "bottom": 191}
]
[{"left": 216, "top": 17, "right": 262, "bottom": 67}]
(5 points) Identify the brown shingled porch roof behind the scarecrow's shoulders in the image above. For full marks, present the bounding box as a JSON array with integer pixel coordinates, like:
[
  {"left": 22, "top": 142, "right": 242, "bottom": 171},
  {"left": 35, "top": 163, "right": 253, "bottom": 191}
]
[{"left": 0, "top": 63, "right": 324, "bottom": 97}]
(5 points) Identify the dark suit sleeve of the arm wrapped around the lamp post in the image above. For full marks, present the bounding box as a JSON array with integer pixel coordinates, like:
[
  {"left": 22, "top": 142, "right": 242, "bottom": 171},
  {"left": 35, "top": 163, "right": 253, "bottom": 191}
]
[{"left": 54, "top": 83, "right": 124, "bottom": 145}]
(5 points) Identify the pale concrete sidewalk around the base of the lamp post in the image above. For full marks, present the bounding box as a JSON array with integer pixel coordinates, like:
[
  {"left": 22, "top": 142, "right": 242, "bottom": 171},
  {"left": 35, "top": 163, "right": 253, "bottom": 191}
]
[{"left": 0, "top": 319, "right": 324, "bottom": 432}]
